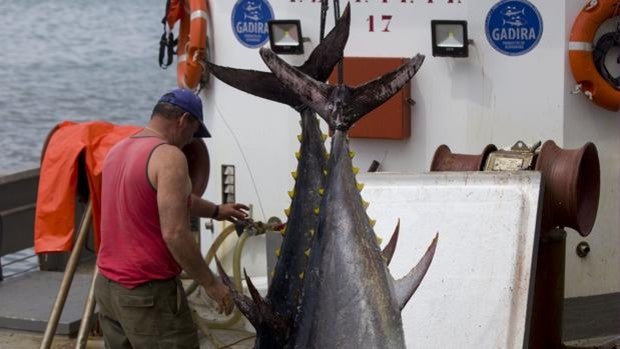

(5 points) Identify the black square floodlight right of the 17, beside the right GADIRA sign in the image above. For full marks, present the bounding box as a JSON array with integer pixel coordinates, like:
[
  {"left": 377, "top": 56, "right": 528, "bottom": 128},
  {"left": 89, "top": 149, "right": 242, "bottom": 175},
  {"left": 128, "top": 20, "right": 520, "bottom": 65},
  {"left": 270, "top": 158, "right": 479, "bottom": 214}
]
[{"left": 431, "top": 20, "right": 469, "bottom": 57}]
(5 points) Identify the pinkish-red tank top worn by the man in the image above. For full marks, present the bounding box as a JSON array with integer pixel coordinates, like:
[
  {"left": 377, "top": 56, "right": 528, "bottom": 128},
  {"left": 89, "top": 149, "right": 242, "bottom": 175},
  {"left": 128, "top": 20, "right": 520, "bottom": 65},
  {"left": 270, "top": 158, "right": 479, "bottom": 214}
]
[{"left": 97, "top": 137, "right": 181, "bottom": 288}]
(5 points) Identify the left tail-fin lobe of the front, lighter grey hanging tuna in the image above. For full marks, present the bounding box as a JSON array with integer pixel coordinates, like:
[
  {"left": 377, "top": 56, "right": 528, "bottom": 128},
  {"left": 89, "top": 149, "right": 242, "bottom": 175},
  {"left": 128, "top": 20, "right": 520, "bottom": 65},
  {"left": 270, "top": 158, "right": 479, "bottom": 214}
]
[{"left": 260, "top": 47, "right": 334, "bottom": 125}]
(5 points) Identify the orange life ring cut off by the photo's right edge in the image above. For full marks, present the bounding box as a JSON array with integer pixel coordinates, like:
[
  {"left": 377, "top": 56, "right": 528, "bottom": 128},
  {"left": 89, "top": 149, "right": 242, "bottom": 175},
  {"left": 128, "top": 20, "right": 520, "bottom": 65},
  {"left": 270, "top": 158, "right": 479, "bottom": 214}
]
[{"left": 568, "top": 0, "right": 620, "bottom": 111}]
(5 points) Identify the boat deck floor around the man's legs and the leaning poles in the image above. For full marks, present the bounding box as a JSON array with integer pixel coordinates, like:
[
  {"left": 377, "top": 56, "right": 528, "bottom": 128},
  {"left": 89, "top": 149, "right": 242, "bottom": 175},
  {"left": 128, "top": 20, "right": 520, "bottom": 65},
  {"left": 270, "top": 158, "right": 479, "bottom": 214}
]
[{"left": 0, "top": 250, "right": 255, "bottom": 349}]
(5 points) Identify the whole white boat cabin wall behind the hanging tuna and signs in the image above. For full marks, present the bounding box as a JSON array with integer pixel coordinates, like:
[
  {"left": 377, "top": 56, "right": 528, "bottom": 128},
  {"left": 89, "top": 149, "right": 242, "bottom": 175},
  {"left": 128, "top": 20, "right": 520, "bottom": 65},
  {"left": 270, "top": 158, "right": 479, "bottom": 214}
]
[{"left": 205, "top": 0, "right": 620, "bottom": 296}]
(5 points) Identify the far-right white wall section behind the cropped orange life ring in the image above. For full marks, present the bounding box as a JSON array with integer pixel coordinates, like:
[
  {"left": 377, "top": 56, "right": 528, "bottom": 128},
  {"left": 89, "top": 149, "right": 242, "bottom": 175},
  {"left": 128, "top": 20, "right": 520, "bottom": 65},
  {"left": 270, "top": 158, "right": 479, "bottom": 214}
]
[{"left": 563, "top": 0, "right": 620, "bottom": 297}]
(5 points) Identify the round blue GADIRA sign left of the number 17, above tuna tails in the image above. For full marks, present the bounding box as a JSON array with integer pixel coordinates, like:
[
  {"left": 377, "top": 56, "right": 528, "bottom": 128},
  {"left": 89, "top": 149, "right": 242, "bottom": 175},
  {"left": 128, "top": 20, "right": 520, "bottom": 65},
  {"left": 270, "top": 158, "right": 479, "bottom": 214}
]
[{"left": 230, "top": 0, "right": 273, "bottom": 48}]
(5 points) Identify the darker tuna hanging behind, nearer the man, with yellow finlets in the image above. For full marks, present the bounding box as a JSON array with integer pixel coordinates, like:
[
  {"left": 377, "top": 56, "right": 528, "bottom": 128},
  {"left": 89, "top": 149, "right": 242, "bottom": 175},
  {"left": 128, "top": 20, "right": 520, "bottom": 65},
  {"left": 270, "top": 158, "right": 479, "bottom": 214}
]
[{"left": 207, "top": 6, "right": 350, "bottom": 348}]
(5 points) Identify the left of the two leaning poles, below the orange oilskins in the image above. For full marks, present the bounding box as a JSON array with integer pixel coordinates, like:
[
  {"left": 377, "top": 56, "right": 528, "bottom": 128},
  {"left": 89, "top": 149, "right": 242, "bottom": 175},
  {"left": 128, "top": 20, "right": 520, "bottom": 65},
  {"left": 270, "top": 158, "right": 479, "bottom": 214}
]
[{"left": 41, "top": 200, "right": 92, "bottom": 349}]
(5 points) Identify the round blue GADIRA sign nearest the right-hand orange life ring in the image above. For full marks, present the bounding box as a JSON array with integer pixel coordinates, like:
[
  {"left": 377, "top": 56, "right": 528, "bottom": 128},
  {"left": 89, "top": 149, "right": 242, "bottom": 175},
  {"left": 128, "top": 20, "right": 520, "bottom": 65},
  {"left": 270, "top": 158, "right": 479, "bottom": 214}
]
[{"left": 485, "top": 0, "right": 543, "bottom": 56}]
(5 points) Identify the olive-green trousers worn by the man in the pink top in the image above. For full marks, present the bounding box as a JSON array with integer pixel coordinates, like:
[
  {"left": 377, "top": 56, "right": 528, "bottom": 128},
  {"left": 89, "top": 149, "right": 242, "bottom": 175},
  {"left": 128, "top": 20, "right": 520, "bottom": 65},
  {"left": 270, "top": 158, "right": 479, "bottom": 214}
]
[{"left": 95, "top": 274, "right": 199, "bottom": 349}]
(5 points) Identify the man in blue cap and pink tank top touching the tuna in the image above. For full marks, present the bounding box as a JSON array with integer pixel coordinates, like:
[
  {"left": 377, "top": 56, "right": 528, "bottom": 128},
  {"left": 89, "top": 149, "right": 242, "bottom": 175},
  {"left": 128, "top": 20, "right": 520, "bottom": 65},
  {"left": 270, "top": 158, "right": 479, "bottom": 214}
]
[{"left": 95, "top": 89, "right": 248, "bottom": 349}]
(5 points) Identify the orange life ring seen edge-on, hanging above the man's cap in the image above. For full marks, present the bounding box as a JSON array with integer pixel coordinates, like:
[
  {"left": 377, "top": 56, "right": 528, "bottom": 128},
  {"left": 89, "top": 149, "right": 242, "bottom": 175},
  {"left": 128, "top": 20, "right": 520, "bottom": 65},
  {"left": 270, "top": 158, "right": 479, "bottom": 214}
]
[{"left": 177, "top": 0, "right": 208, "bottom": 90}]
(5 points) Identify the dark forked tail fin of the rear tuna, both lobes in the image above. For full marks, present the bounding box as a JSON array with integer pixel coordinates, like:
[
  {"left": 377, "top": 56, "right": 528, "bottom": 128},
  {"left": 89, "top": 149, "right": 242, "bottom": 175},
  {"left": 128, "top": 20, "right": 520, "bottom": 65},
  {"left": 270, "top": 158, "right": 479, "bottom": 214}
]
[{"left": 207, "top": 5, "right": 351, "bottom": 109}]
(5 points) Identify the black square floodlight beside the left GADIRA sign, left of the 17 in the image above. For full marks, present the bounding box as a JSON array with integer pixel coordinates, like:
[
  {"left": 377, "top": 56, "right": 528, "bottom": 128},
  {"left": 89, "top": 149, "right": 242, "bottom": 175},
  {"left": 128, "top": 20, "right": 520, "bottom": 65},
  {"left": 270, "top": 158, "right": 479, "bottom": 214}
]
[{"left": 267, "top": 19, "right": 304, "bottom": 55}]
